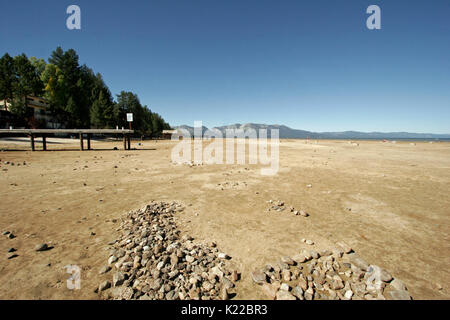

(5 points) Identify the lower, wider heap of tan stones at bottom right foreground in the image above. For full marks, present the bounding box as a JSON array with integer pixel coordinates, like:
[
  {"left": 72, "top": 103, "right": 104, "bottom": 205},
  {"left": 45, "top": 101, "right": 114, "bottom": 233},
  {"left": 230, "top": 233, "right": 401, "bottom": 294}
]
[{"left": 251, "top": 244, "right": 411, "bottom": 300}]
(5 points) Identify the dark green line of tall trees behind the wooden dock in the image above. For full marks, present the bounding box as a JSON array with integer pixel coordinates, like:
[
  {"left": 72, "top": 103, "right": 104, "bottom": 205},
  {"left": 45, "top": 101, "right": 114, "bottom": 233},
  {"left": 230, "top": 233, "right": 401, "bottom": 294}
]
[{"left": 0, "top": 47, "right": 170, "bottom": 136}]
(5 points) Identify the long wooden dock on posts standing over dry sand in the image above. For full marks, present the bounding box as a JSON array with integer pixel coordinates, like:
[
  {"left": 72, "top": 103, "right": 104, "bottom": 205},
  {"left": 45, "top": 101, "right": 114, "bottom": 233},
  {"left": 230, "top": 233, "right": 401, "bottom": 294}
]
[{"left": 0, "top": 129, "right": 134, "bottom": 151}]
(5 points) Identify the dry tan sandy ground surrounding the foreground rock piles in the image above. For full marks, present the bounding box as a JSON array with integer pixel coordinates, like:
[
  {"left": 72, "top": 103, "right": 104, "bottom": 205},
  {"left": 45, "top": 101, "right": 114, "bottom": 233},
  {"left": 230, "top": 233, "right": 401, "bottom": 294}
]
[{"left": 0, "top": 139, "right": 450, "bottom": 299}]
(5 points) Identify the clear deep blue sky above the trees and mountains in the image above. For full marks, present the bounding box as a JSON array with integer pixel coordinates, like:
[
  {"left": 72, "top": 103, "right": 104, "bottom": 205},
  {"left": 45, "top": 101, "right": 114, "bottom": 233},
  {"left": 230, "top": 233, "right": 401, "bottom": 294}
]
[{"left": 0, "top": 0, "right": 450, "bottom": 133}]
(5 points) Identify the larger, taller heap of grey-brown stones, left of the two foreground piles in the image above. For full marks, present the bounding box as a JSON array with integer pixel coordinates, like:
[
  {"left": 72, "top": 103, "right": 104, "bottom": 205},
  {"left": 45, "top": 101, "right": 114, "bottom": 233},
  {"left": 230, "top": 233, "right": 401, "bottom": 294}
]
[{"left": 96, "top": 202, "right": 239, "bottom": 300}]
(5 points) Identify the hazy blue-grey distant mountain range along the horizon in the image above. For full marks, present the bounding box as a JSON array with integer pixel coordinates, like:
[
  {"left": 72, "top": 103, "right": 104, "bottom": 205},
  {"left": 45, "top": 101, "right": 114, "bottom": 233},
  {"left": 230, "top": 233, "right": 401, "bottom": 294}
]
[{"left": 175, "top": 123, "right": 450, "bottom": 140}]
